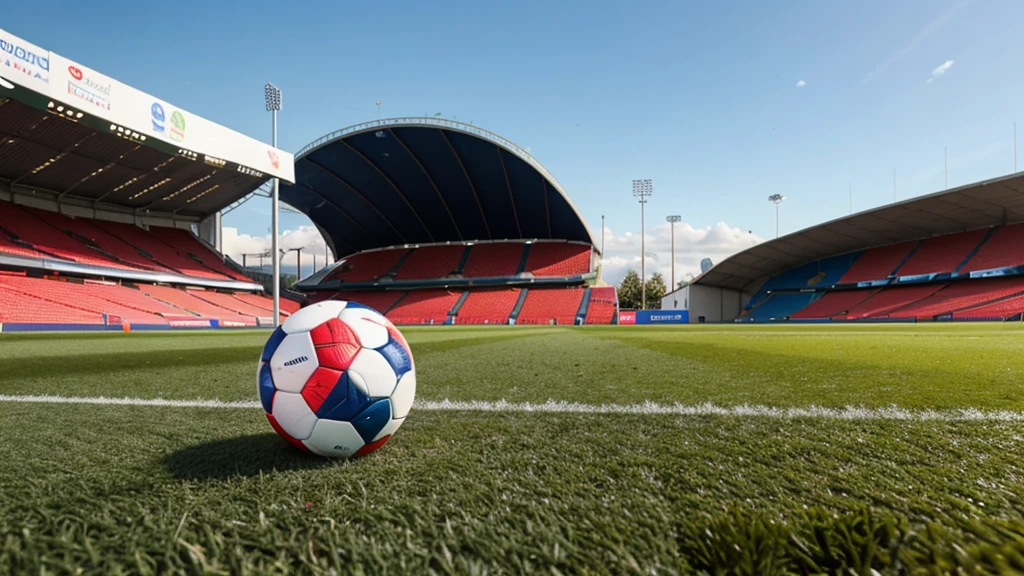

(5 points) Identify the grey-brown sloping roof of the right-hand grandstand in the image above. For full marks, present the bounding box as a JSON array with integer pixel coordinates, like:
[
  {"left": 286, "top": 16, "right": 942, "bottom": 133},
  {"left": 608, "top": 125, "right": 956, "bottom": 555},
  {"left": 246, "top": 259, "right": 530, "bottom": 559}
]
[{"left": 694, "top": 170, "right": 1024, "bottom": 291}]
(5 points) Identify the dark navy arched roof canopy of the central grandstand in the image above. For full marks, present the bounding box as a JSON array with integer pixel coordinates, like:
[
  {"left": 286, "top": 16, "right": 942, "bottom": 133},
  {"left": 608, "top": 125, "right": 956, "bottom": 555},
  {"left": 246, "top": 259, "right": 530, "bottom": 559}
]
[{"left": 281, "top": 118, "right": 594, "bottom": 258}]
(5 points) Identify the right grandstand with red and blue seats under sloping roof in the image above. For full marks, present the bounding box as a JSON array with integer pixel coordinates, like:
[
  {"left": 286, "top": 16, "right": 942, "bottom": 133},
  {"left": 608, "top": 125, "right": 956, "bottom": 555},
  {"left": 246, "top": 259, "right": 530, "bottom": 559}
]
[{"left": 675, "top": 170, "right": 1024, "bottom": 322}]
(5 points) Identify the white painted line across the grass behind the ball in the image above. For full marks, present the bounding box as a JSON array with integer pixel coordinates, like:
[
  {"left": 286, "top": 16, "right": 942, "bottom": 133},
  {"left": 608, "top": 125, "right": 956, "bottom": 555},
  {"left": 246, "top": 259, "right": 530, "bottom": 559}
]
[{"left": 0, "top": 395, "right": 1024, "bottom": 422}]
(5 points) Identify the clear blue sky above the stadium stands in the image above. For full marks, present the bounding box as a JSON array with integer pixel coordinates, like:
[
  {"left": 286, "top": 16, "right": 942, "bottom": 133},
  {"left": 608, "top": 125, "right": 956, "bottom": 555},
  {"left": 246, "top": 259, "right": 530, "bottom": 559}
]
[{"left": 2, "top": 0, "right": 1024, "bottom": 278}]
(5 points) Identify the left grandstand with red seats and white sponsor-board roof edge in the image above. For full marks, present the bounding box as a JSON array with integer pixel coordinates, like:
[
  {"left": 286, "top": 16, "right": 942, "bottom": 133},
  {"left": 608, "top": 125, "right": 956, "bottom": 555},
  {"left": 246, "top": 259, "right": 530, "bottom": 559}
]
[{"left": 0, "top": 30, "right": 300, "bottom": 331}]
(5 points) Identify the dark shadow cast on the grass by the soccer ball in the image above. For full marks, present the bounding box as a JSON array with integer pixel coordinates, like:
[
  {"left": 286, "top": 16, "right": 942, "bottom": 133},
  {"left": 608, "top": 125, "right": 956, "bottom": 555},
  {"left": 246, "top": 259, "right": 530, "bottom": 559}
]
[{"left": 164, "top": 433, "right": 332, "bottom": 480}]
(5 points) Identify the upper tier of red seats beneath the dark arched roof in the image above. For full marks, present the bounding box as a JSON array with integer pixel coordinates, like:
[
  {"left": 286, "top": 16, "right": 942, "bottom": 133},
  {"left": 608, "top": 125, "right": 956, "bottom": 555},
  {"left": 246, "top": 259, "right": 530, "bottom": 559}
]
[{"left": 325, "top": 242, "right": 591, "bottom": 283}]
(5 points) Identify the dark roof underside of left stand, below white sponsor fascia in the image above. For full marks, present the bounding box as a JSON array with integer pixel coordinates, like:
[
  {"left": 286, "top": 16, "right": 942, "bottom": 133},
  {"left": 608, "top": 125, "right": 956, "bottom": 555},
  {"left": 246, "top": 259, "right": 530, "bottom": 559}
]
[{"left": 0, "top": 97, "right": 267, "bottom": 219}]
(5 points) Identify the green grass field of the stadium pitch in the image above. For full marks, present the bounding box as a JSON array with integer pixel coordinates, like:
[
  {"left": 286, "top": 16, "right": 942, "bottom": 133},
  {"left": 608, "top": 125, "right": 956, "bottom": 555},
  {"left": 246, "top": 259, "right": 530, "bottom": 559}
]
[{"left": 0, "top": 324, "right": 1024, "bottom": 575}]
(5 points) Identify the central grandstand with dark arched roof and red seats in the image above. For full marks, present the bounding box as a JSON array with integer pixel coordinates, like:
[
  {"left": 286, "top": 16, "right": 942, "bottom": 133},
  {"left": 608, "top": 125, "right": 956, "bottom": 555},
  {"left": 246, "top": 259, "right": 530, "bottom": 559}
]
[{"left": 281, "top": 118, "right": 617, "bottom": 325}]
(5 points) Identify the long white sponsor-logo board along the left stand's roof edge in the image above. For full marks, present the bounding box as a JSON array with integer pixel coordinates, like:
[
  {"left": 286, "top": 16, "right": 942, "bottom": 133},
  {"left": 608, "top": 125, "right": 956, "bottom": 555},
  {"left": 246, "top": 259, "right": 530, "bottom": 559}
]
[{"left": 0, "top": 30, "right": 295, "bottom": 181}]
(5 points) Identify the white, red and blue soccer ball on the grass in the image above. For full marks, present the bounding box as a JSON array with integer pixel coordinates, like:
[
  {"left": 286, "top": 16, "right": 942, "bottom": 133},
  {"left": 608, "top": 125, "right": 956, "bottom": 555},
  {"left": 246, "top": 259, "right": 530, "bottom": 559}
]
[{"left": 257, "top": 300, "right": 416, "bottom": 458}]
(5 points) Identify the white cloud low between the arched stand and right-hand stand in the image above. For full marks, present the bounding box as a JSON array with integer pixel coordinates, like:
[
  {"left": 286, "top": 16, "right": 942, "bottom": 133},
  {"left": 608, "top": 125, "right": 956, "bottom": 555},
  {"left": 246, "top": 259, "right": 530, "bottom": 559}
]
[{"left": 598, "top": 222, "right": 764, "bottom": 284}]
